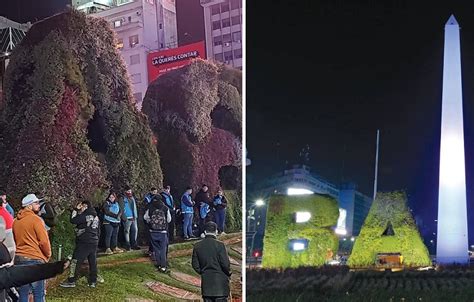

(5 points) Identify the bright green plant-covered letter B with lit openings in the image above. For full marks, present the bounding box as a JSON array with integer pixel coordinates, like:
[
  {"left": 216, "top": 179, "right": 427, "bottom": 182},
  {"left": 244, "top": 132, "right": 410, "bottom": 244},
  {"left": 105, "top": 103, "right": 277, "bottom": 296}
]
[{"left": 262, "top": 194, "right": 339, "bottom": 268}]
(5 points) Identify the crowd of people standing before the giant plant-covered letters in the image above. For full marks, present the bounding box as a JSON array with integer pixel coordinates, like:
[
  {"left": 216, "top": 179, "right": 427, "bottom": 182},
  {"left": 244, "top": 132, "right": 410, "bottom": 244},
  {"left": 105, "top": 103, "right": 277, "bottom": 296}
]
[{"left": 0, "top": 185, "right": 230, "bottom": 302}]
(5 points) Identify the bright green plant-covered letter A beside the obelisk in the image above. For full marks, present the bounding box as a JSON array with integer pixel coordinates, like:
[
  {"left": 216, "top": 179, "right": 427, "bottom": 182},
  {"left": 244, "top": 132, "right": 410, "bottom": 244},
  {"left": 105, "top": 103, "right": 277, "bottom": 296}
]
[{"left": 348, "top": 192, "right": 431, "bottom": 267}]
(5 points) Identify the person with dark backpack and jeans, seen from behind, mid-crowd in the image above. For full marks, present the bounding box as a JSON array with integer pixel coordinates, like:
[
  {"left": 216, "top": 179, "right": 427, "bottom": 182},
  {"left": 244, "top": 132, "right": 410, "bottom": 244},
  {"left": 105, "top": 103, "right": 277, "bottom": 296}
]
[{"left": 143, "top": 195, "right": 171, "bottom": 273}]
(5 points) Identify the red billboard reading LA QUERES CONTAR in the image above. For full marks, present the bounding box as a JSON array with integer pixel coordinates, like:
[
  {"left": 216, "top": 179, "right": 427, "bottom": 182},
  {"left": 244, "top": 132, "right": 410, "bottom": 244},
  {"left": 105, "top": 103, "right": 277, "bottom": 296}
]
[{"left": 147, "top": 41, "right": 206, "bottom": 83}]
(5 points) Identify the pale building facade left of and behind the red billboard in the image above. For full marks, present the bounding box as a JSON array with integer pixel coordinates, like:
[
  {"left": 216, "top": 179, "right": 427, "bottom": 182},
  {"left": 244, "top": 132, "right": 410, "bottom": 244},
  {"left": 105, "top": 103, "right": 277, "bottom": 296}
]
[{"left": 73, "top": 0, "right": 178, "bottom": 109}]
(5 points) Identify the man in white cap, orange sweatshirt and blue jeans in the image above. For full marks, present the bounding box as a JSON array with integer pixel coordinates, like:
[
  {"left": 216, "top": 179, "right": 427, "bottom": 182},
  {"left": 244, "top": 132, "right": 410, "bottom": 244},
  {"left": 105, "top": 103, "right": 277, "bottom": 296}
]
[{"left": 13, "top": 194, "right": 51, "bottom": 302}]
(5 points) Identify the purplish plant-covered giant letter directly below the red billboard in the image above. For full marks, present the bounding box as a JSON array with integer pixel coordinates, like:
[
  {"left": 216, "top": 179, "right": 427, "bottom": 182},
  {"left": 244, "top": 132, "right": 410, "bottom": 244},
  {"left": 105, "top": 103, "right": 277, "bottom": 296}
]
[{"left": 142, "top": 60, "right": 242, "bottom": 193}]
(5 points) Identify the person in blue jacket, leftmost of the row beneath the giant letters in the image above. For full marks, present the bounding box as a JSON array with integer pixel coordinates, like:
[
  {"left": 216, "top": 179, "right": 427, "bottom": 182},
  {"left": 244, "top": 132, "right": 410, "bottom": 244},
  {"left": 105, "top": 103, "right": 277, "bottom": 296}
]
[{"left": 103, "top": 192, "right": 123, "bottom": 255}]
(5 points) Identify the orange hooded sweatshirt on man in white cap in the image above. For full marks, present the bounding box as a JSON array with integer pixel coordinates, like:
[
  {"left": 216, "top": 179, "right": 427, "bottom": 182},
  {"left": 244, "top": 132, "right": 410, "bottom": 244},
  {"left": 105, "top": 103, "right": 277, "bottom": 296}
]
[{"left": 13, "top": 209, "right": 51, "bottom": 262}]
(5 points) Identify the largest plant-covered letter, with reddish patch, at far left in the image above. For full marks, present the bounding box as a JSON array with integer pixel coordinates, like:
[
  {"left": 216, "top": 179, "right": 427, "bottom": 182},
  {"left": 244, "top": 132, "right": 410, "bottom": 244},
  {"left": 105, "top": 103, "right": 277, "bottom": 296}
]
[{"left": 0, "top": 11, "right": 162, "bottom": 209}]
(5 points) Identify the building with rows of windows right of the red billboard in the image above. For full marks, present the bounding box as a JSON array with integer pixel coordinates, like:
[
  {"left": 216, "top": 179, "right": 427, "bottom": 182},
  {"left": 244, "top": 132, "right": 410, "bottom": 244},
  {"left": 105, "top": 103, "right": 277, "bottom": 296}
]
[{"left": 201, "top": 0, "right": 243, "bottom": 69}]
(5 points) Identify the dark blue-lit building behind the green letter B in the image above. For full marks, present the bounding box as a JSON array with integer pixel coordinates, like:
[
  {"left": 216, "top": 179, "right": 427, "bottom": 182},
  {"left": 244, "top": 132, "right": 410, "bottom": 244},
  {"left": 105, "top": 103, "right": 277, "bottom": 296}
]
[{"left": 247, "top": 165, "right": 372, "bottom": 252}]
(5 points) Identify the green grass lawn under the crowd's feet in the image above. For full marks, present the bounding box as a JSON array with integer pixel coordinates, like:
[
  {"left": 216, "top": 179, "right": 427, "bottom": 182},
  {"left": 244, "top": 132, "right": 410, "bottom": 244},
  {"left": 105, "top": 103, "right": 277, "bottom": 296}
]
[{"left": 46, "top": 234, "right": 242, "bottom": 302}]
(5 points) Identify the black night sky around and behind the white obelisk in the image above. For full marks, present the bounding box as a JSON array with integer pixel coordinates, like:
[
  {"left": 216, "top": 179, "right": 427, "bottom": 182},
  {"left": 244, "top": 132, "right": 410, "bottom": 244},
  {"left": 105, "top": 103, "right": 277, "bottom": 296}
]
[{"left": 247, "top": 0, "right": 474, "bottom": 244}]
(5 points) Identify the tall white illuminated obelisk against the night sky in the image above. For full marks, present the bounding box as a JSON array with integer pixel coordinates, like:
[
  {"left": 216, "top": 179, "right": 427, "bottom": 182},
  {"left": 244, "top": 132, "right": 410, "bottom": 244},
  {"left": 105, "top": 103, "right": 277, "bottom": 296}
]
[{"left": 436, "top": 15, "right": 468, "bottom": 264}]
